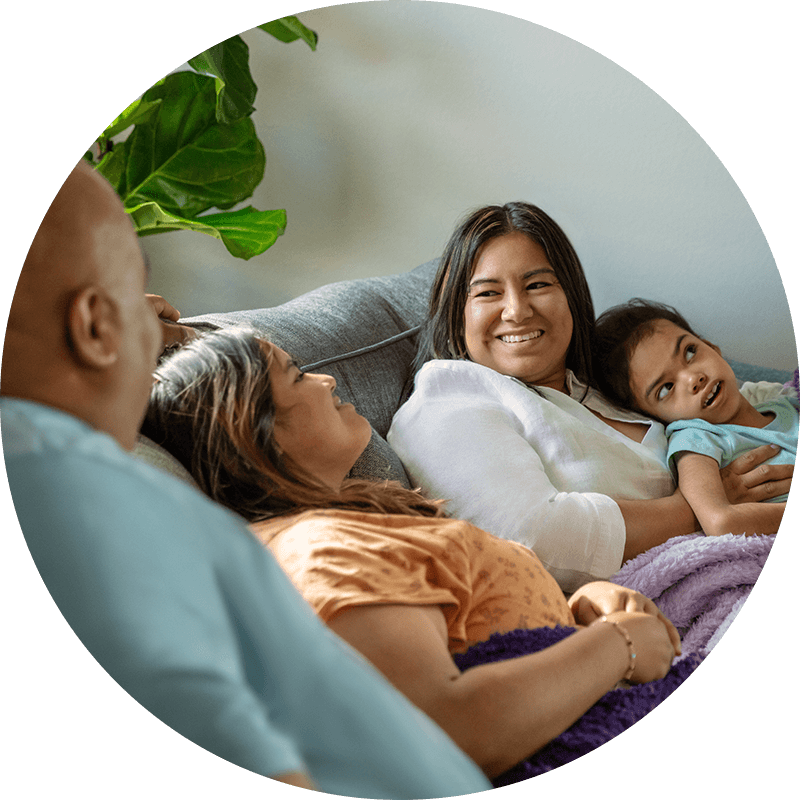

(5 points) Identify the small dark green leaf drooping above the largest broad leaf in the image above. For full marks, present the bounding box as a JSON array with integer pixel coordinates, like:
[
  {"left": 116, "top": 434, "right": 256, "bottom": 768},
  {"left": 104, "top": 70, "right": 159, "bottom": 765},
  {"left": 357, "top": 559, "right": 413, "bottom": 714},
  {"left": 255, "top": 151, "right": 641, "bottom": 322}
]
[{"left": 189, "top": 36, "right": 258, "bottom": 124}]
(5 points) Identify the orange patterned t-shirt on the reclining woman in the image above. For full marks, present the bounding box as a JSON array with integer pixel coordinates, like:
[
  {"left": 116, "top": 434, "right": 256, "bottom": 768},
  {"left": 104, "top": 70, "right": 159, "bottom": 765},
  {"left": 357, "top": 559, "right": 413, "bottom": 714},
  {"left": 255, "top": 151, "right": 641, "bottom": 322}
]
[{"left": 251, "top": 509, "right": 575, "bottom": 652}]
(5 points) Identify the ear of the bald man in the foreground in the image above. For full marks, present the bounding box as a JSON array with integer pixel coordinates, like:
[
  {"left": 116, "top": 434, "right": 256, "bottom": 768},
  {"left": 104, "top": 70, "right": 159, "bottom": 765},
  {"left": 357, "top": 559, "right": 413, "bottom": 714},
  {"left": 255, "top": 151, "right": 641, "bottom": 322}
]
[{"left": 67, "top": 286, "right": 121, "bottom": 369}]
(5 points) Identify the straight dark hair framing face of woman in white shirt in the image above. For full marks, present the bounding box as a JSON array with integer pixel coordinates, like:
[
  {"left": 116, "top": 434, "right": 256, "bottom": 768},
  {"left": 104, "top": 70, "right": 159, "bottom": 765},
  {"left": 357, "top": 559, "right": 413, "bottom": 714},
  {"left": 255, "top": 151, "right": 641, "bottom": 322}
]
[{"left": 414, "top": 202, "right": 594, "bottom": 384}]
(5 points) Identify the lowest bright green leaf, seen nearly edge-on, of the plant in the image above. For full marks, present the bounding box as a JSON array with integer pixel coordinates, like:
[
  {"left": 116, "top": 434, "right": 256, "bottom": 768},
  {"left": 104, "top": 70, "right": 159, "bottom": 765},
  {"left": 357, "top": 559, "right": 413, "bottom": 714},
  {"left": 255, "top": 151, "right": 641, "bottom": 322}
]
[{"left": 128, "top": 202, "right": 286, "bottom": 260}]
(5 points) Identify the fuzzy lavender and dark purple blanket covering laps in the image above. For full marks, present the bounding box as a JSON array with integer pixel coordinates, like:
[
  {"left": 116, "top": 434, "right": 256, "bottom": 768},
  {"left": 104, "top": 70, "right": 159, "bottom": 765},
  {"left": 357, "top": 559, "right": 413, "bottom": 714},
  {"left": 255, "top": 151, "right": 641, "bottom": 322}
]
[{"left": 454, "top": 534, "right": 775, "bottom": 786}]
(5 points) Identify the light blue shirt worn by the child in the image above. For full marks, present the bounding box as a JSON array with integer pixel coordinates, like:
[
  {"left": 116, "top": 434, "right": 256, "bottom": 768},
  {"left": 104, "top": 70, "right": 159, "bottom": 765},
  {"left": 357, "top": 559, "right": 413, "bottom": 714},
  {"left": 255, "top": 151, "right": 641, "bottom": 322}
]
[{"left": 667, "top": 396, "right": 800, "bottom": 503}]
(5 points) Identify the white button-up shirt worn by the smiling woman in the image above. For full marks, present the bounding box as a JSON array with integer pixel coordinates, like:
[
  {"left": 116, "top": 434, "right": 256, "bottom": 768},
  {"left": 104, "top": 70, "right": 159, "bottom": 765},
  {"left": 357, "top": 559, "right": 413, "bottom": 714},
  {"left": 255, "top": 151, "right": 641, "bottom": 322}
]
[{"left": 387, "top": 361, "right": 675, "bottom": 591}]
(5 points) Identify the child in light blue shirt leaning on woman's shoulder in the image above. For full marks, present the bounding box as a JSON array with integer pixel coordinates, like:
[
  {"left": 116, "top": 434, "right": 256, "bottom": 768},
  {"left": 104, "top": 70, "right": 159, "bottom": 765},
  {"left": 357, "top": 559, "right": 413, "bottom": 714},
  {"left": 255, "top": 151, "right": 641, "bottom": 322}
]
[{"left": 595, "top": 299, "right": 798, "bottom": 536}]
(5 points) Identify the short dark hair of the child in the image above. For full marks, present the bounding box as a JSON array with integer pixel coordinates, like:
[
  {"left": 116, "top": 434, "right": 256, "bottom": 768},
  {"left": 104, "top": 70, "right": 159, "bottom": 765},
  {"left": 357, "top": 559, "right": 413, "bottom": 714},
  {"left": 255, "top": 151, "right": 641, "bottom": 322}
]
[{"left": 592, "top": 297, "right": 697, "bottom": 411}]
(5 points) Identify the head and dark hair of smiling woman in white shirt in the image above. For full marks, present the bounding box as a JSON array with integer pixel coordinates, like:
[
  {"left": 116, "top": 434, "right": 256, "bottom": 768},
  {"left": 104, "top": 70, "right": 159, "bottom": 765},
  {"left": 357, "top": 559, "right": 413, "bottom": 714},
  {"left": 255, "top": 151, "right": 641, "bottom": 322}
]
[{"left": 415, "top": 203, "right": 594, "bottom": 390}]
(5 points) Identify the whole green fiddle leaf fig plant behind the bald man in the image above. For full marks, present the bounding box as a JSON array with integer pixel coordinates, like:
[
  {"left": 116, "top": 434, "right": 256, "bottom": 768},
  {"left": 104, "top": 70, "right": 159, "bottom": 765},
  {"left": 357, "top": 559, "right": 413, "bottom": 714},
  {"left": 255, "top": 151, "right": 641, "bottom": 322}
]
[{"left": 85, "top": 17, "right": 317, "bottom": 259}]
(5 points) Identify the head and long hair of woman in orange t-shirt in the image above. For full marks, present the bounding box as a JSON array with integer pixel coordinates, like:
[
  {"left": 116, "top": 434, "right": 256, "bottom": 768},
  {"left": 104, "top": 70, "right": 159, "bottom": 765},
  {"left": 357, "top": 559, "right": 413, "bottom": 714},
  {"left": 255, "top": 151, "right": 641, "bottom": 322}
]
[{"left": 142, "top": 326, "right": 441, "bottom": 521}]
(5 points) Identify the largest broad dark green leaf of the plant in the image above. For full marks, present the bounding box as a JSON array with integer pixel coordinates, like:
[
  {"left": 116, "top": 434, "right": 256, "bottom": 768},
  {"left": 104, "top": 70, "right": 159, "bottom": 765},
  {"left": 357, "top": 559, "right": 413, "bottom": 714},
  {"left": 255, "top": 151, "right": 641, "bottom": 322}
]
[{"left": 97, "top": 72, "right": 266, "bottom": 218}]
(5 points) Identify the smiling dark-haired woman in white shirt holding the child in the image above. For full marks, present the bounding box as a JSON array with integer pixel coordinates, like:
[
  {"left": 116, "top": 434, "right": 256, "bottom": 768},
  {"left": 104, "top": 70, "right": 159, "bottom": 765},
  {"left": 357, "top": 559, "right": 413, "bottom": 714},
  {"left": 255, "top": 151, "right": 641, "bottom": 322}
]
[{"left": 387, "top": 202, "right": 792, "bottom": 591}]
